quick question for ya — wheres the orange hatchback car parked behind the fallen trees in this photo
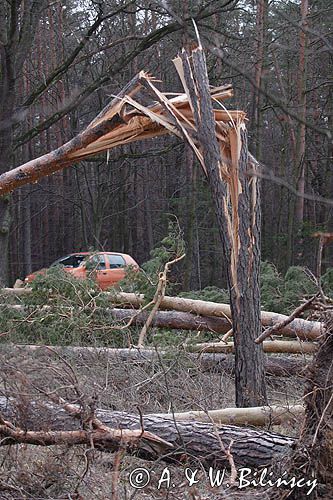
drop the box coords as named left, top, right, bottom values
left=24, top=252, right=139, bottom=290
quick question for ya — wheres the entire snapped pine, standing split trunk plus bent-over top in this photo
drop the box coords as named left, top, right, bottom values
left=0, top=46, right=267, bottom=407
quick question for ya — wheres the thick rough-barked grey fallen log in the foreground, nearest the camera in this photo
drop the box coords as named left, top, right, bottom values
left=0, top=397, right=295, bottom=467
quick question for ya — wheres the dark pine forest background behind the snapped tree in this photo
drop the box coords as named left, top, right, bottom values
left=0, top=0, right=333, bottom=290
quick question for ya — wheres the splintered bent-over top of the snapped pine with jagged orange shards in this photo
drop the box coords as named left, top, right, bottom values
left=0, top=68, right=246, bottom=196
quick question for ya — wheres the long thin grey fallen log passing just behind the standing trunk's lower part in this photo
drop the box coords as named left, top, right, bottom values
left=1, top=344, right=307, bottom=377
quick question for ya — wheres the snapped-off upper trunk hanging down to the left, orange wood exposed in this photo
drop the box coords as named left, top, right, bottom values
left=0, top=71, right=237, bottom=196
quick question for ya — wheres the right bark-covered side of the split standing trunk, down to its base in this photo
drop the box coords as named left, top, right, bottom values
left=228, top=130, right=267, bottom=407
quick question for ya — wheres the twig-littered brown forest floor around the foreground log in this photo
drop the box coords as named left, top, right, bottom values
left=0, top=347, right=303, bottom=500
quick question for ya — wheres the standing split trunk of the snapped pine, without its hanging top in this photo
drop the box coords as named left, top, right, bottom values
left=182, top=47, right=267, bottom=407
